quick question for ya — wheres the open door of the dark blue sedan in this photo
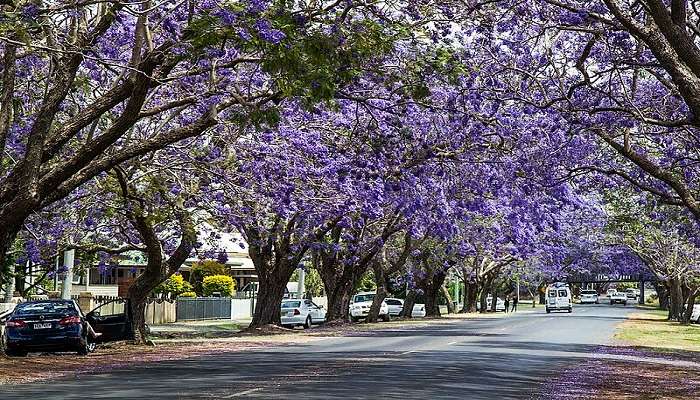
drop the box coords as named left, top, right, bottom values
left=85, top=299, right=134, bottom=343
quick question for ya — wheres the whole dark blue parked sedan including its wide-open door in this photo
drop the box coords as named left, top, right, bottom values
left=2, top=300, right=133, bottom=356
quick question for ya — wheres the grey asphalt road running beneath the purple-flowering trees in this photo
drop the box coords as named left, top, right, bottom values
left=0, top=304, right=634, bottom=400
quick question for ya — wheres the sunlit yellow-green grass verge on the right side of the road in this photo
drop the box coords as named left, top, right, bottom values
left=615, top=307, right=700, bottom=352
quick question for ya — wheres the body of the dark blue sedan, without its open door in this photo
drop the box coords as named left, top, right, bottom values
left=2, top=300, right=95, bottom=356
